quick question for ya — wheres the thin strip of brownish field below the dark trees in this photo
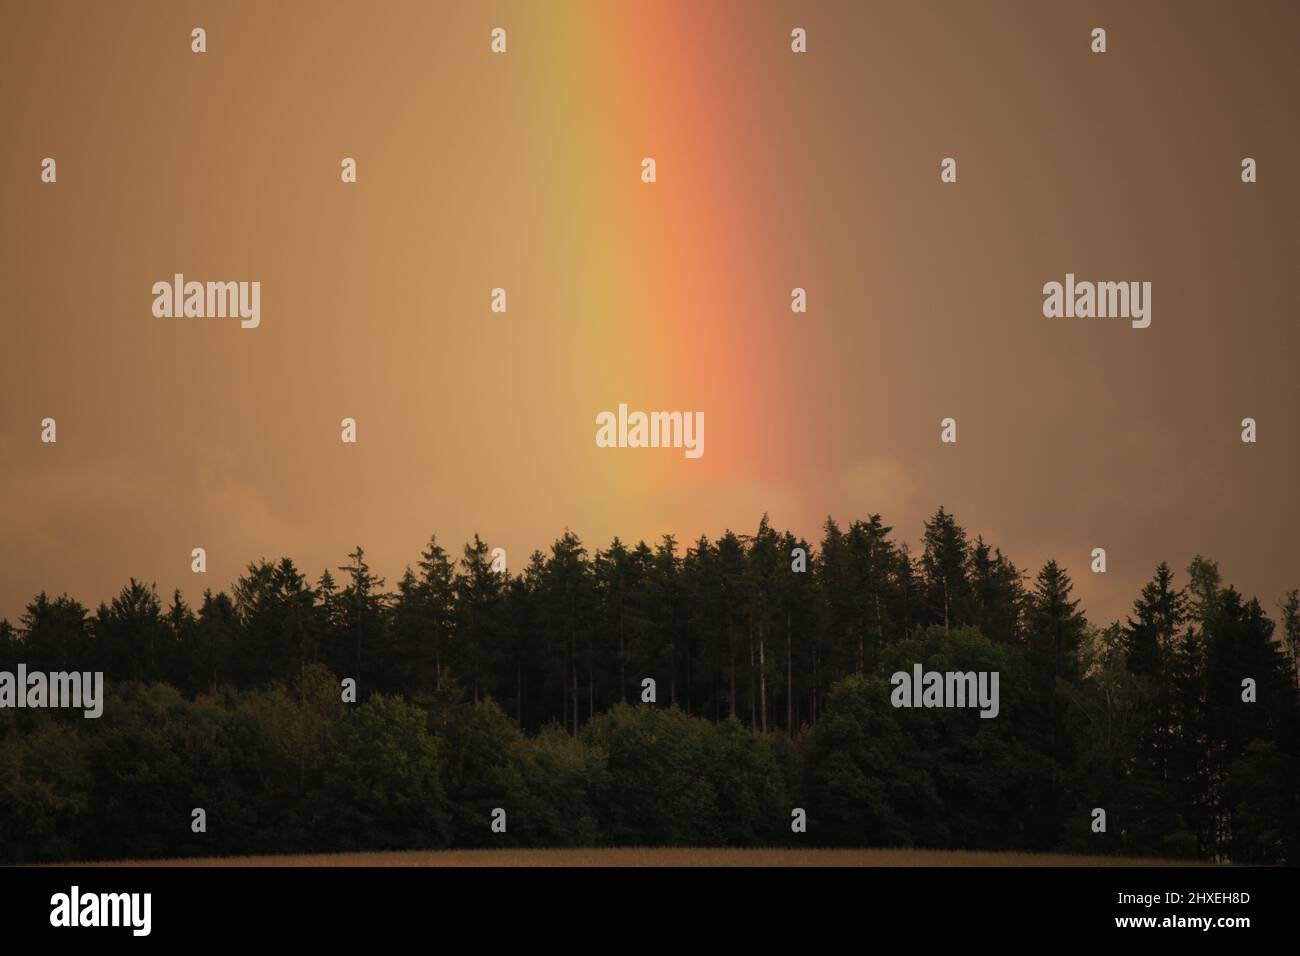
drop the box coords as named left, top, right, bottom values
left=76, top=847, right=1201, bottom=866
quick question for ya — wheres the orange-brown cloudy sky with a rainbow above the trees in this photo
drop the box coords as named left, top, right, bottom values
left=0, top=0, right=1300, bottom=623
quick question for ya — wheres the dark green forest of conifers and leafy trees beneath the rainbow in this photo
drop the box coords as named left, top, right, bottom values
left=0, top=510, right=1300, bottom=862
